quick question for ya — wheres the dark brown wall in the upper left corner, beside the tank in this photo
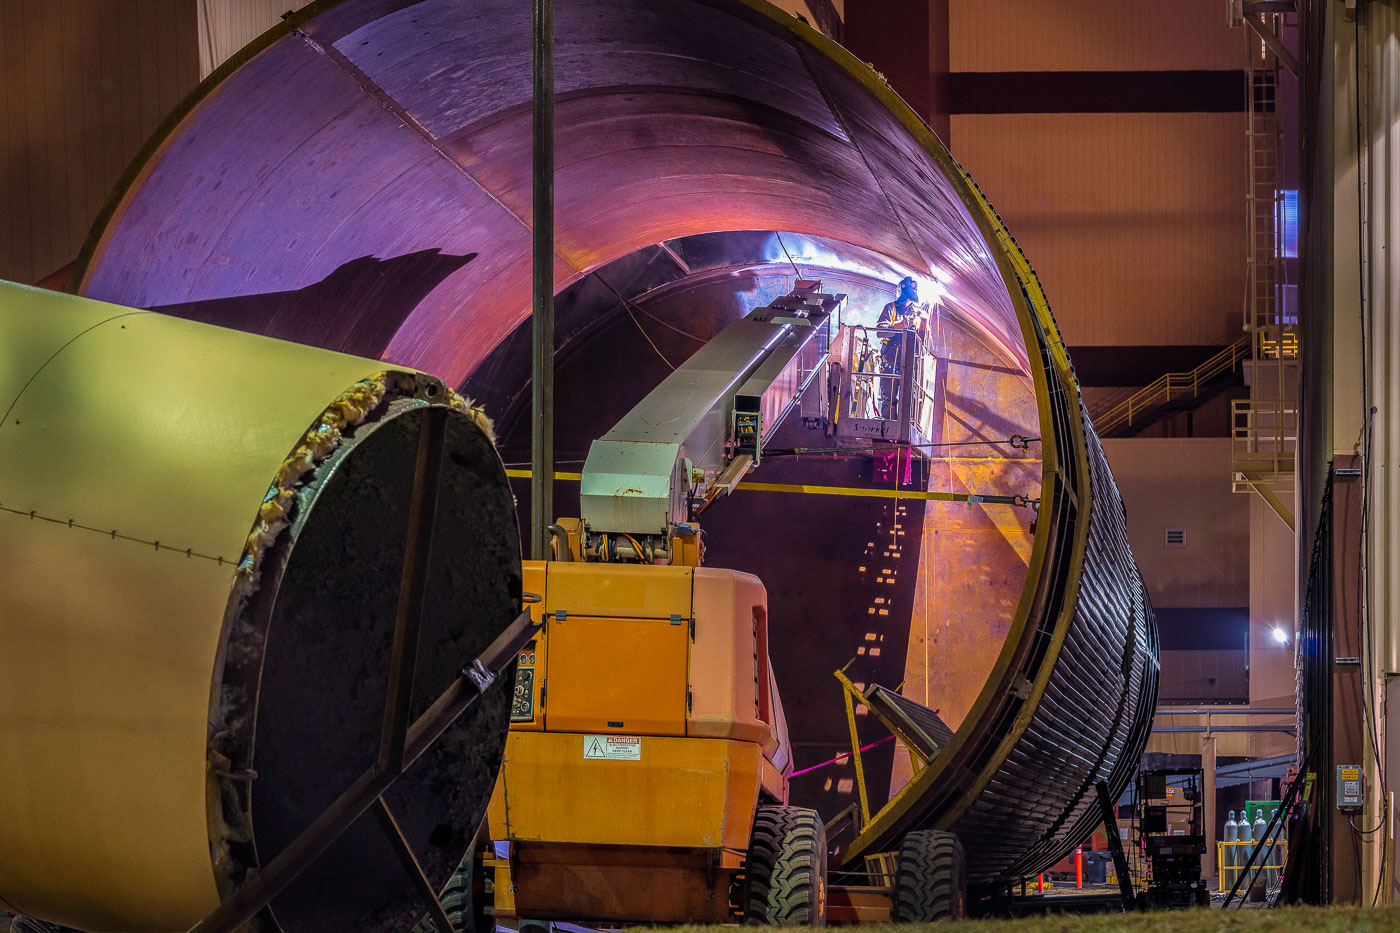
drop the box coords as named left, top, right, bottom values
left=0, top=0, right=199, bottom=282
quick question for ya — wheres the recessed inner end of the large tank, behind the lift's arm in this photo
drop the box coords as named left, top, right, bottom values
left=466, top=231, right=1040, bottom=815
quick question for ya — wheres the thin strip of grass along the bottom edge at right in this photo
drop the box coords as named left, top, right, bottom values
left=668, top=906, right=1400, bottom=933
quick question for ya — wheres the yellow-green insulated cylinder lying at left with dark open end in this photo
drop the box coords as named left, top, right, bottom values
left=0, top=283, right=521, bottom=933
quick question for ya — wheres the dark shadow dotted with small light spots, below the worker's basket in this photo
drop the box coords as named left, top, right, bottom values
left=700, top=406, right=925, bottom=823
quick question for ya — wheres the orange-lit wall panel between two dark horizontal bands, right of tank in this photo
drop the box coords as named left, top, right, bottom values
left=952, top=113, right=1247, bottom=344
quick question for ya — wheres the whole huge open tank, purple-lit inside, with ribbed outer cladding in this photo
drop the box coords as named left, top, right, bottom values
left=65, top=0, right=1156, bottom=902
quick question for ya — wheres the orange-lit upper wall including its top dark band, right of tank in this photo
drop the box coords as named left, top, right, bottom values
left=949, top=0, right=1247, bottom=354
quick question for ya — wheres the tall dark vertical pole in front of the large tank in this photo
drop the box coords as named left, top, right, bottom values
left=529, top=0, right=554, bottom=560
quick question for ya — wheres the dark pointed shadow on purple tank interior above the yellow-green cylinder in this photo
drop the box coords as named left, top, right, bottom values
left=150, top=248, right=477, bottom=357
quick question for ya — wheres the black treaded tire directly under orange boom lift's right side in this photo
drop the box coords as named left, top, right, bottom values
left=743, top=807, right=826, bottom=926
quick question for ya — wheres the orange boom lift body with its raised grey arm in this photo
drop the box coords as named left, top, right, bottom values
left=482, top=282, right=844, bottom=925
